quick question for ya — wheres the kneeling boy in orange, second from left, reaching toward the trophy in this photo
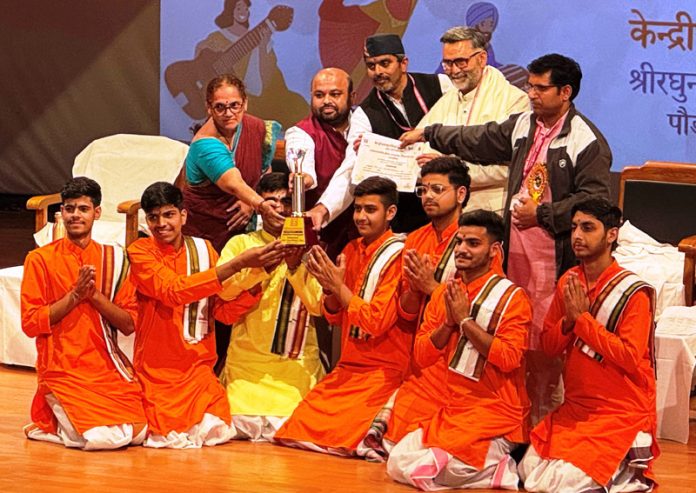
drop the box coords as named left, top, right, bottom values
left=128, top=182, right=282, bottom=448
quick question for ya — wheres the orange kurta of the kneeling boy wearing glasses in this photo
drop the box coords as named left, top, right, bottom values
left=385, top=220, right=458, bottom=442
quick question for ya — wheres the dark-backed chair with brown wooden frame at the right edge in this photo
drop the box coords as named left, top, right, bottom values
left=619, top=161, right=696, bottom=306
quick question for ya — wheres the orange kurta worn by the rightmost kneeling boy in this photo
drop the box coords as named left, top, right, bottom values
left=531, top=261, right=659, bottom=485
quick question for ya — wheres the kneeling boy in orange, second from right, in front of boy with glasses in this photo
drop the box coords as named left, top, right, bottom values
left=387, top=210, right=531, bottom=490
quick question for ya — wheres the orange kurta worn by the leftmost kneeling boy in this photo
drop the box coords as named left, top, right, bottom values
left=21, top=238, right=146, bottom=434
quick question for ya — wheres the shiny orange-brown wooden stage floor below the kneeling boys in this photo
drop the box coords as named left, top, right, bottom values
left=0, top=365, right=696, bottom=493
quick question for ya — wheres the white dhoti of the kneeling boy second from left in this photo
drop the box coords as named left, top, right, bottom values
left=143, top=413, right=237, bottom=449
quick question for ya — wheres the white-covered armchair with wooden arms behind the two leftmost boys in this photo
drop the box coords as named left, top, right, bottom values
left=0, top=134, right=188, bottom=366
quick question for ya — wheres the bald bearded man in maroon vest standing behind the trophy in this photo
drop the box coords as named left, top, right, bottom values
left=285, top=68, right=358, bottom=260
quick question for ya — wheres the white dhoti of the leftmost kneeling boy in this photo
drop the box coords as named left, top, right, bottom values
left=24, top=394, right=147, bottom=450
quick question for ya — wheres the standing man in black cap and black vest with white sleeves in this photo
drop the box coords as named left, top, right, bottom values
left=309, top=34, right=452, bottom=232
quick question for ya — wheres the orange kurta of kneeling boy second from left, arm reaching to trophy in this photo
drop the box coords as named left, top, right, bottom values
left=128, top=238, right=231, bottom=435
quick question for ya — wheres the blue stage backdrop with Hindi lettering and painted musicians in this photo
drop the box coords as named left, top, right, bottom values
left=160, top=0, right=696, bottom=170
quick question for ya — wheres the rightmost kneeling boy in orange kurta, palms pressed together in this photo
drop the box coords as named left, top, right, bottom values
left=520, top=199, right=659, bottom=493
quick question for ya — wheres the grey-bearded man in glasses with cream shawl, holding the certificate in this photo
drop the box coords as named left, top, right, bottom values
left=418, top=26, right=529, bottom=215
